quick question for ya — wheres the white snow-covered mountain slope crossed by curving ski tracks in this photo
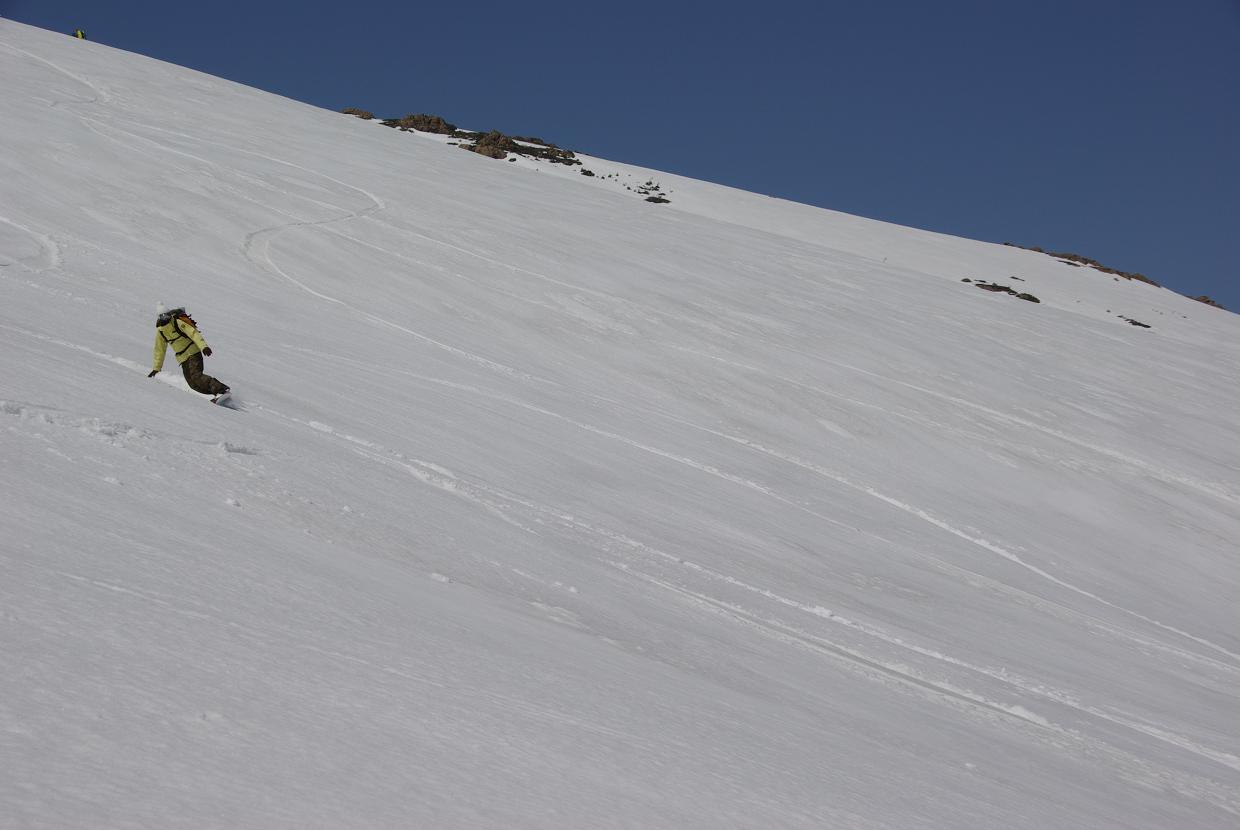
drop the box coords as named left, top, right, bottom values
left=0, top=21, right=1240, bottom=830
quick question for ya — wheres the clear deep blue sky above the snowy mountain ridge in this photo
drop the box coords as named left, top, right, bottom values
left=0, top=0, right=1240, bottom=311
